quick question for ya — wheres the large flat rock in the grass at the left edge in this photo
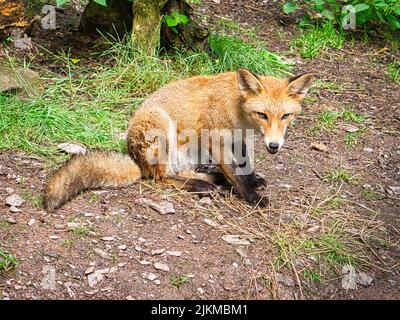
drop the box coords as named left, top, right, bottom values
left=0, top=66, right=43, bottom=96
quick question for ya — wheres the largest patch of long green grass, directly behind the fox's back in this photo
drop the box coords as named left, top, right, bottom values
left=0, top=36, right=291, bottom=160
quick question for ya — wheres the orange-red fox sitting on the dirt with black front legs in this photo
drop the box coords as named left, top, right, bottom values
left=44, top=69, right=314, bottom=210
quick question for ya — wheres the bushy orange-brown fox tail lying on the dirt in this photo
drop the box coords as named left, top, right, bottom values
left=44, top=151, right=141, bottom=210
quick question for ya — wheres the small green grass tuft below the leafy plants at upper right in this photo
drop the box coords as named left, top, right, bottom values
left=290, top=22, right=345, bottom=59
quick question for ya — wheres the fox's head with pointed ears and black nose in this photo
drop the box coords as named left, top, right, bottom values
left=237, top=69, right=314, bottom=153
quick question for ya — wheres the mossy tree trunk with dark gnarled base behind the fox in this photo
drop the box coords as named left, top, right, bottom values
left=78, top=0, right=209, bottom=55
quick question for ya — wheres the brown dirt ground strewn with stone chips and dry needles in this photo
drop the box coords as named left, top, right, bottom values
left=0, top=0, right=400, bottom=299
